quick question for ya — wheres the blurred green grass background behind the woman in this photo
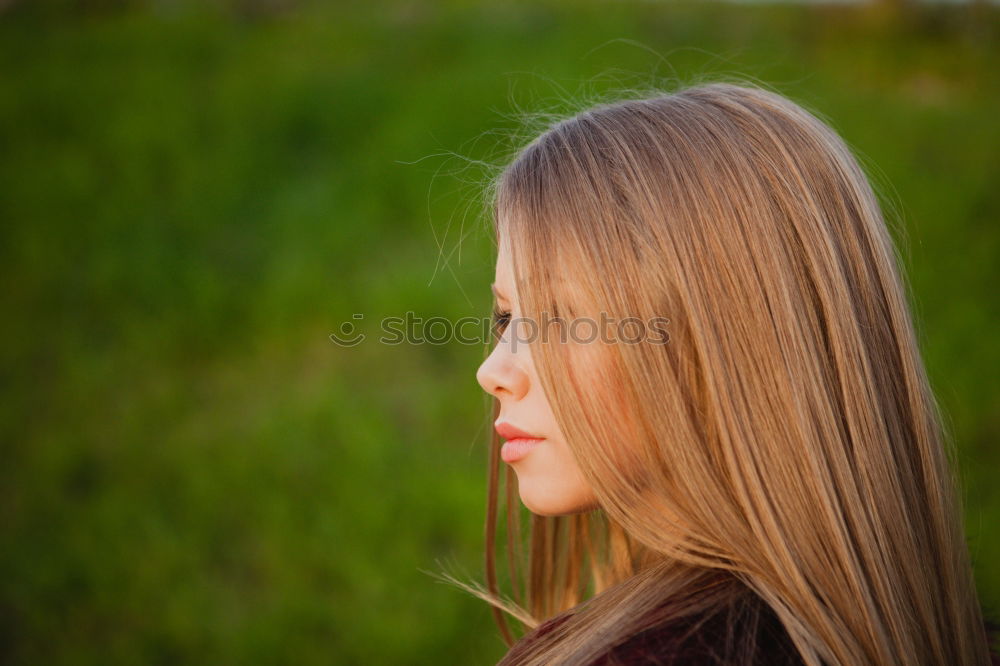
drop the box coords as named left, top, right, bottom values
left=0, top=2, right=1000, bottom=664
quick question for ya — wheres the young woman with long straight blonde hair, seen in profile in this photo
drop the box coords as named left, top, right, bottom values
left=467, top=83, right=990, bottom=665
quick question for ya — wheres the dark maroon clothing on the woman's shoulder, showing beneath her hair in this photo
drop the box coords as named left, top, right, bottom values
left=593, top=592, right=804, bottom=666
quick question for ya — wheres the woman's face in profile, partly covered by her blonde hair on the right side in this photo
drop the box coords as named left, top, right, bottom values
left=476, top=237, right=597, bottom=515
